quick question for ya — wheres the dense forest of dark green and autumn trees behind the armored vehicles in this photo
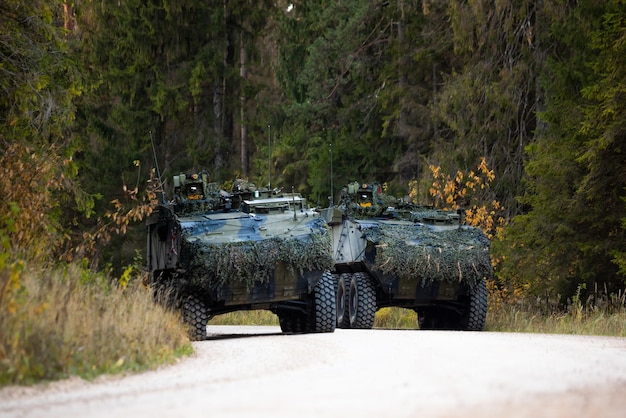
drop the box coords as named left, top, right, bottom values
left=0, top=0, right=626, bottom=304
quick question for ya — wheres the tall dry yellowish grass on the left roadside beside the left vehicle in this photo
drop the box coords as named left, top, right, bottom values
left=0, top=265, right=191, bottom=385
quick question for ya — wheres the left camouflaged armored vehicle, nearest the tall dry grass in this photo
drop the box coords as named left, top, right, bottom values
left=147, top=173, right=336, bottom=340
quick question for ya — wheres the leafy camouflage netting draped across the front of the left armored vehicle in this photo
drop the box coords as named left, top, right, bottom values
left=181, top=230, right=333, bottom=289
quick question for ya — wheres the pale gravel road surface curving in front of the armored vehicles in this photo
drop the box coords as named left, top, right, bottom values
left=0, top=326, right=626, bottom=418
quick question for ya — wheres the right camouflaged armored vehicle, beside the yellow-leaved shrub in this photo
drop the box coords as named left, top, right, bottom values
left=322, top=182, right=492, bottom=331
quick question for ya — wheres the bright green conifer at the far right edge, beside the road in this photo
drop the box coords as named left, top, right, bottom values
left=501, top=2, right=626, bottom=296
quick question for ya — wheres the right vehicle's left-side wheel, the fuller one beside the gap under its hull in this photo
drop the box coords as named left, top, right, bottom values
left=348, top=273, right=376, bottom=329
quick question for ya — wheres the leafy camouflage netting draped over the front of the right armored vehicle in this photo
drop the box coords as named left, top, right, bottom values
left=365, top=225, right=492, bottom=287
